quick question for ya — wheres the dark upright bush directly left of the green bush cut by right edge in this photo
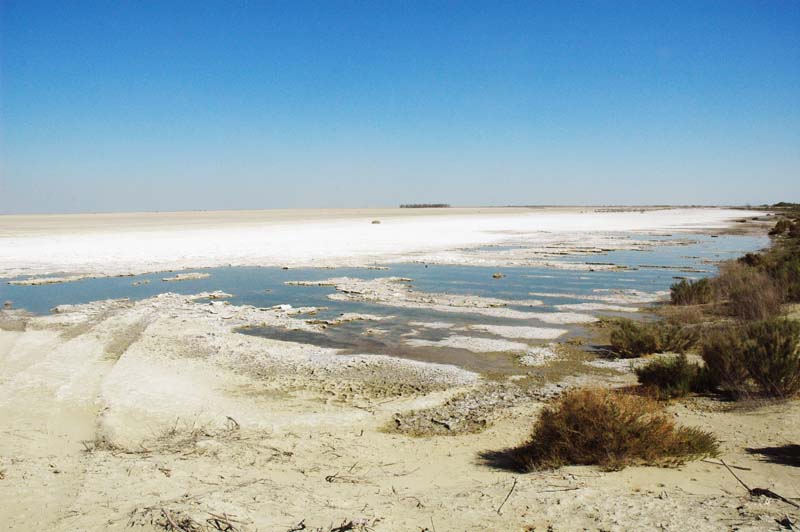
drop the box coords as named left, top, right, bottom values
left=697, top=327, right=749, bottom=396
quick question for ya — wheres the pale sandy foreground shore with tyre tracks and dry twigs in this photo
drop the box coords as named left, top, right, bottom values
left=0, top=294, right=800, bottom=531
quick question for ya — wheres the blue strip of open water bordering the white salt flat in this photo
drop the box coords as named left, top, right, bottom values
left=0, top=235, right=769, bottom=315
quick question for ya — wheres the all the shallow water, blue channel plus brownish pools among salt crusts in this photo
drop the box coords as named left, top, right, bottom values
left=0, top=235, right=769, bottom=374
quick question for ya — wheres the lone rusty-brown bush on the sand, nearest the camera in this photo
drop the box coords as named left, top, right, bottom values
left=513, top=389, right=718, bottom=471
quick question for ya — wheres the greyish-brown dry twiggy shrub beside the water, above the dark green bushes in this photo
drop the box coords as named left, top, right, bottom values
left=716, top=261, right=783, bottom=320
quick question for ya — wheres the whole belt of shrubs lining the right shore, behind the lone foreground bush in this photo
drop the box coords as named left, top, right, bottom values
left=648, top=204, right=800, bottom=398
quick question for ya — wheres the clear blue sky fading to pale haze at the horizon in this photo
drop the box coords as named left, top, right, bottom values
left=0, top=0, right=800, bottom=213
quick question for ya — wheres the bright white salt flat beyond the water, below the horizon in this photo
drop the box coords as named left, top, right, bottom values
left=0, top=208, right=763, bottom=277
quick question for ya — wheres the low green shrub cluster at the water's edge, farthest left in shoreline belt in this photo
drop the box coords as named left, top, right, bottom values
left=609, top=319, right=698, bottom=358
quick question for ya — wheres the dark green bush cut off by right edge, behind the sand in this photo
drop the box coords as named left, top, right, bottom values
left=743, top=319, right=800, bottom=397
